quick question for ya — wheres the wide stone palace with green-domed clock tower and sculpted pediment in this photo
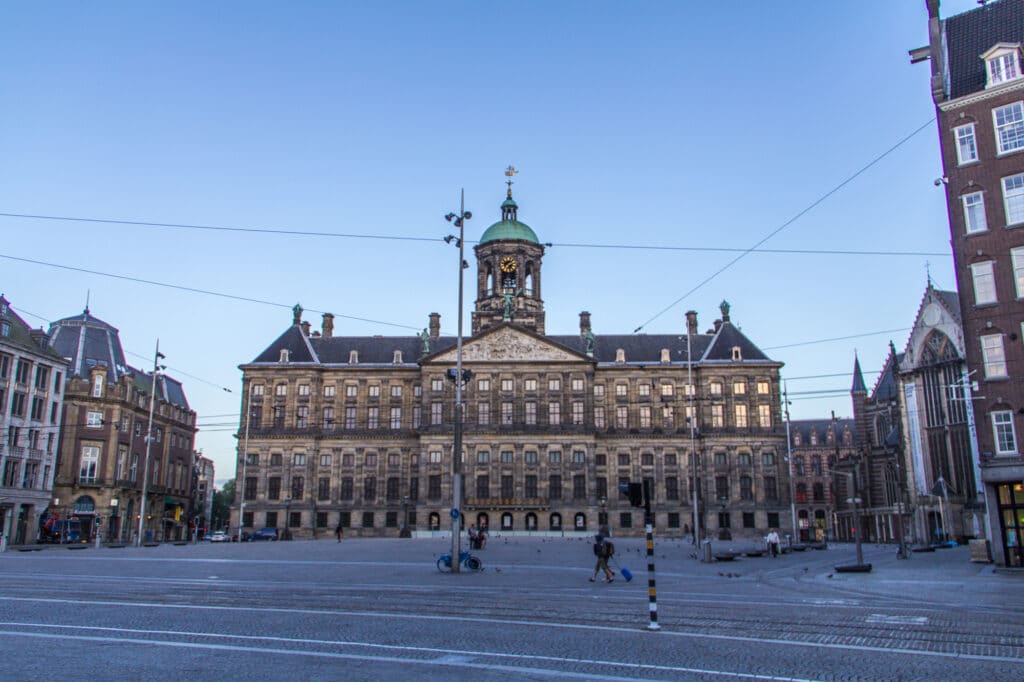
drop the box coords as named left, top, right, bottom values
left=232, top=183, right=792, bottom=538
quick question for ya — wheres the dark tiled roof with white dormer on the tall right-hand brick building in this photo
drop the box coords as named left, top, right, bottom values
left=943, top=0, right=1024, bottom=99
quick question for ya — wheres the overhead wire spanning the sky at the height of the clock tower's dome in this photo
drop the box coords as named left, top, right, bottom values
left=0, top=213, right=950, bottom=258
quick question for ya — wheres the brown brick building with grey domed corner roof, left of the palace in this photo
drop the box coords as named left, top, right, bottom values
left=49, top=308, right=196, bottom=542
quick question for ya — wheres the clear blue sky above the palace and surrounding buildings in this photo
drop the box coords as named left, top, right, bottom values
left=0, top=0, right=976, bottom=479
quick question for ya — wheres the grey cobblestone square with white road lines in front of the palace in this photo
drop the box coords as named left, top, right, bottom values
left=0, top=536, right=1024, bottom=682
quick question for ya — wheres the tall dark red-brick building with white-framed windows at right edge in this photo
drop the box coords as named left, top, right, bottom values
left=910, top=0, right=1024, bottom=566
